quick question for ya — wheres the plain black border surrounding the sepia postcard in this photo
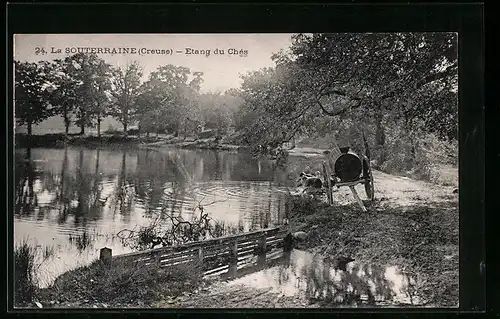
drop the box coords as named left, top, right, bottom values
left=6, top=2, right=490, bottom=317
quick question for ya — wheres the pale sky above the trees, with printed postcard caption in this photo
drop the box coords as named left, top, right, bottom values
left=14, top=33, right=291, bottom=92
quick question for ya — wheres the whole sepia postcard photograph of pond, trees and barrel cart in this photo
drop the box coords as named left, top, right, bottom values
left=12, top=32, right=459, bottom=309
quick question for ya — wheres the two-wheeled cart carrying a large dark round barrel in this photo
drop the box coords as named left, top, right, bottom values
left=323, top=147, right=375, bottom=211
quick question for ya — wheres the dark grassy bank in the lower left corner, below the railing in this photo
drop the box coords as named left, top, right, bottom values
left=15, top=245, right=206, bottom=308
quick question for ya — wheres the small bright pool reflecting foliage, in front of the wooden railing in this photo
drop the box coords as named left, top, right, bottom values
left=228, top=249, right=424, bottom=307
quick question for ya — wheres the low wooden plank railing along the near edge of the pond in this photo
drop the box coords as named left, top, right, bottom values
left=100, top=226, right=287, bottom=271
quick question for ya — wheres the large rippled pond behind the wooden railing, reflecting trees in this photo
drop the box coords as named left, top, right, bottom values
left=14, top=147, right=304, bottom=286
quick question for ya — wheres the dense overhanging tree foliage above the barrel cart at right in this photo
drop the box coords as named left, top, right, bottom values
left=233, top=33, right=458, bottom=175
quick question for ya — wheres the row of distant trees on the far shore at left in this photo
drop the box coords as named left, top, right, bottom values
left=15, top=53, right=244, bottom=140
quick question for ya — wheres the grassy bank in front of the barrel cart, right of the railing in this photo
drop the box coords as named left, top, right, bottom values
left=284, top=194, right=459, bottom=307
